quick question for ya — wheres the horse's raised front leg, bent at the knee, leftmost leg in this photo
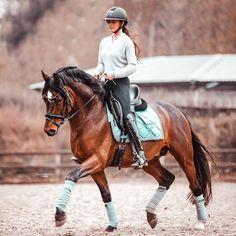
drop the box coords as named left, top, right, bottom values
left=55, top=155, right=104, bottom=227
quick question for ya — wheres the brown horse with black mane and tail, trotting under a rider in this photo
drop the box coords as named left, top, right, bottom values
left=42, top=67, right=212, bottom=231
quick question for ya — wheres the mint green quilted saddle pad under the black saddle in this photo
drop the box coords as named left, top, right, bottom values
left=106, top=106, right=164, bottom=143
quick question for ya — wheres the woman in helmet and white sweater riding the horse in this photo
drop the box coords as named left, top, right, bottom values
left=95, top=7, right=147, bottom=168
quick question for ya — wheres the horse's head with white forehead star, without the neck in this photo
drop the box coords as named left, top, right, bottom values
left=41, top=71, right=73, bottom=136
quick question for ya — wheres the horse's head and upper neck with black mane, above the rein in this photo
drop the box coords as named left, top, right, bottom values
left=42, top=67, right=105, bottom=136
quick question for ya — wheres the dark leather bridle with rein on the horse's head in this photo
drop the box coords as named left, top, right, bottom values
left=43, top=92, right=96, bottom=128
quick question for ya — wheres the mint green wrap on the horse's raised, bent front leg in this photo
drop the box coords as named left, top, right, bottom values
left=56, top=180, right=75, bottom=211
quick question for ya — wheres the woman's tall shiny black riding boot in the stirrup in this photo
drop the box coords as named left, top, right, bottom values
left=125, top=114, right=148, bottom=169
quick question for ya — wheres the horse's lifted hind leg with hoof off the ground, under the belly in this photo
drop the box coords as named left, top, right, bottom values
left=143, top=159, right=175, bottom=228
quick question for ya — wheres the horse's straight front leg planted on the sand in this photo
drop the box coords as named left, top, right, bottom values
left=92, top=171, right=118, bottom=232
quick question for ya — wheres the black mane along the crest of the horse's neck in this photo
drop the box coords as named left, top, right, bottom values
left=44, top=66, right=105, bottom=101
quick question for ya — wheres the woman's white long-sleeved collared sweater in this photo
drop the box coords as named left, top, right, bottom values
left=97, top=33, right=137, bottom=78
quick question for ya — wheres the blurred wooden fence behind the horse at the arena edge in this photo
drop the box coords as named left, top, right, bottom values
left=0, top=148, right=236, bottom=184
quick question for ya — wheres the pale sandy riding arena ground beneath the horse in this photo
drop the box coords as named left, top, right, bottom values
left=0, top=179, right=236, bottom=236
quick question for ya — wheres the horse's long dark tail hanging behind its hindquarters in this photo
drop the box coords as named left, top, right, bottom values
left=188, top=128, right=215, bottom=205
